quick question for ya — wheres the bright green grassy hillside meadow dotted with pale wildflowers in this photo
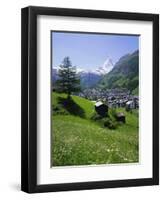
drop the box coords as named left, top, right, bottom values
left=52, top=92, right=138, bottom=166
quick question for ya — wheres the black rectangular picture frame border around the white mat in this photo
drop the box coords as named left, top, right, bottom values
left=21, top=6, right=159, bottom=193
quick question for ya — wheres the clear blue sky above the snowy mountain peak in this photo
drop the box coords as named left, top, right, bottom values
left=52, top=32, right=139, bottom=70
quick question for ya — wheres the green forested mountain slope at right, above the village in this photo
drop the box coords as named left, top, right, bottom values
left=98, top=50, right=139, bottom=94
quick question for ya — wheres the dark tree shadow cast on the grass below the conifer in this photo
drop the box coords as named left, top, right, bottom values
left=58, top=97, right=85, bottom=118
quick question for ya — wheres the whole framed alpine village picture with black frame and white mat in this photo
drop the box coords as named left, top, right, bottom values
left=21, top=6, right=159, bottom=193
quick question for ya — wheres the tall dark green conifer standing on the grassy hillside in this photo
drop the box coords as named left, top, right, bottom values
left=56, top=57, right=80, bottom=98
